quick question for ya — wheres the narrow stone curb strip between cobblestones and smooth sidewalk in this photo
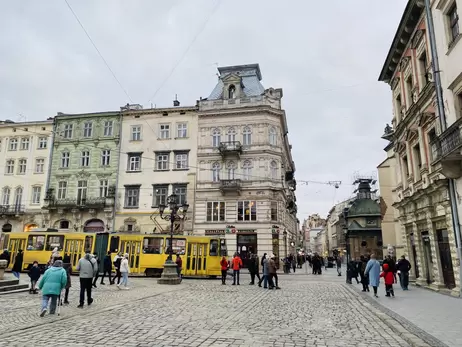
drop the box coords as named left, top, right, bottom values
left=343, top=284, right=449, bottom=347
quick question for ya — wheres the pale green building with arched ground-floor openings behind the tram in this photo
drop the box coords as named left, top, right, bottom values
left=43, top=112, right=121, bottom=232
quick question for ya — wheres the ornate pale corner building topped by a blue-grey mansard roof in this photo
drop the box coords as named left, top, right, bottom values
left=194, top=64, right=297, bottom=262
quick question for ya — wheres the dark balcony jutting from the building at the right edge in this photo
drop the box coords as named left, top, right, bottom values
left=430, top=118, right=462, bottom=179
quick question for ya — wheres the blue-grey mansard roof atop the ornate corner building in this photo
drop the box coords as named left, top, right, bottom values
left=208, top=64, right=265, bottom=100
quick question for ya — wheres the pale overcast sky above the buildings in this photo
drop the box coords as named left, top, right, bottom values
left=0, top=0, right=406, bottom=220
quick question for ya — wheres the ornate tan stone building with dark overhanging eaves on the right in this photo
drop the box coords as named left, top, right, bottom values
left=379, top=0, right=462, bottom=295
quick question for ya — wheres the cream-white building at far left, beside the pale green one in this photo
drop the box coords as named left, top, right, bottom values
left=0, top=120, right=53, bottom=232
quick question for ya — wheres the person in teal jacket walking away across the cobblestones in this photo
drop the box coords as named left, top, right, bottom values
left=38, top=260, right=67, bottom=317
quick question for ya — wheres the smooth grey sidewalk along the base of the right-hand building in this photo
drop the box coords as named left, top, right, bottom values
left=353, top=280, right=462, bottom=347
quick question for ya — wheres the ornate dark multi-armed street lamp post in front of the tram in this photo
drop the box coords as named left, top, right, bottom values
left=157, top=194, right=189, bottom=284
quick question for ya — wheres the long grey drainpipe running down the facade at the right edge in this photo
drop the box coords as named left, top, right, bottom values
left=425, top=0, right=462, bottom=296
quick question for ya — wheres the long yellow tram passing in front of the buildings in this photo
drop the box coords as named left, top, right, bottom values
left=3, top=231, right=227, bottom=277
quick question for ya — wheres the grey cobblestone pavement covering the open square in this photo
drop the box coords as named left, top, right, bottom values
left=0, top=271, right=444, bottom=347
